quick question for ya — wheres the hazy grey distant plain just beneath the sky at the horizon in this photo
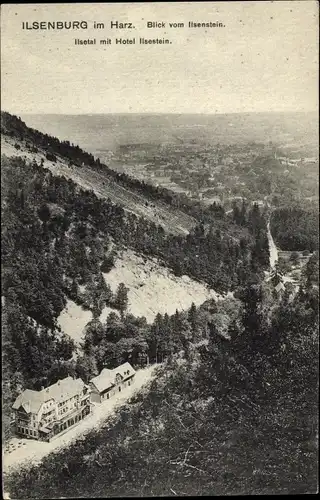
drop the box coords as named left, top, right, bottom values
left=19, top=112, right=318, bottom=152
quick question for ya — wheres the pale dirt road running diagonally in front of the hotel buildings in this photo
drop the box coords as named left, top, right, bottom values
left=3, top=365, right=159, bottom=473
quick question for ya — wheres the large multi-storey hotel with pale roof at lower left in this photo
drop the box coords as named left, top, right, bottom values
left=12, top=377, right=91, bottom=441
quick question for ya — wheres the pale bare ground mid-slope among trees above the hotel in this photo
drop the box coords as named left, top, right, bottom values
left=57, top=249, right=223, bottom=344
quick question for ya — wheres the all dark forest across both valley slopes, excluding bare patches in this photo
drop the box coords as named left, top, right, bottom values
left=1, top=110, right=319, bottom=498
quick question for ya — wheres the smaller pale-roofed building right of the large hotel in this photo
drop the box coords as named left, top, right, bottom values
left=89, top=363, right=136, bottom=403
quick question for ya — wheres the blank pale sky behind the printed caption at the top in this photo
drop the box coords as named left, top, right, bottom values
left=1, top=0, right=318, bottom=114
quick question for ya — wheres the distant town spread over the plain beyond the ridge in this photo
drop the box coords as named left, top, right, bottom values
left=96, top=140, right=319, bottom=209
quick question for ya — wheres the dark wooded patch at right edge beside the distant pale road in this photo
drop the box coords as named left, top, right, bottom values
left=270, top=205, right=319, bottom=252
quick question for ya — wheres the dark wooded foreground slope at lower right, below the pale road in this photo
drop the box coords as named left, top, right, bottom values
left=7, top=278, right=318, bottom=498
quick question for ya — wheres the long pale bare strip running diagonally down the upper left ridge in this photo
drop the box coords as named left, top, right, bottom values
left=1, top=113, right=196, bottom=234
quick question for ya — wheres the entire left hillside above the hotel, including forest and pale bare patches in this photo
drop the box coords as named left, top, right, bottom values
left=1, top=110, right=268, bottom=446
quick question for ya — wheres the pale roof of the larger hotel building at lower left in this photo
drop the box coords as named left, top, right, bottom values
left=12, top=377, right=85, bottom=413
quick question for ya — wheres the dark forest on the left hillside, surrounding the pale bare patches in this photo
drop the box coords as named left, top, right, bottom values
left=2, top=151, right=268, bottom=438
